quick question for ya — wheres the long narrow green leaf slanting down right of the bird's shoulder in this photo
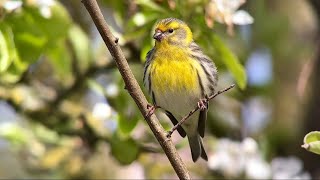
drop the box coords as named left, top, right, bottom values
left=213, top=35, right=247, bottom=89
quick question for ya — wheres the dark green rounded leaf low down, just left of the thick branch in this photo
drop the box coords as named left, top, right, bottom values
left=110, top=134, right=139, bottom=165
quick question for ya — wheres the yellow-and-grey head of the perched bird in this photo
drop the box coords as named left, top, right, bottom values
left=153, top=18, right=193, bottom=46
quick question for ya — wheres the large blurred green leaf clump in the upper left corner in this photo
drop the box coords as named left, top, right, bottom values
left=4, top=2, right=71, bottom=64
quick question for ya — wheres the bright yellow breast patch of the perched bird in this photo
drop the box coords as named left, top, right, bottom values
left=150, top=49, right=199, bottom=93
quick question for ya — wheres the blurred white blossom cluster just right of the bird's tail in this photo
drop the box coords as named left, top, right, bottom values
left=208, top=138, right=271, bottom=179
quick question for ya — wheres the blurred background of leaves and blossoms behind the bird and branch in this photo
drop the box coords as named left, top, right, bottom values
left=0, top=0, right=320, bottom=179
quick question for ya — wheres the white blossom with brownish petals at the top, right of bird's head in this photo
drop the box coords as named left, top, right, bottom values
left=205, top=0, right=254, bottom=35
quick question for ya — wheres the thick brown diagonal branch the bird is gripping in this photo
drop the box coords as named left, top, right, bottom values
left=82, top=0, right=190, bottom=179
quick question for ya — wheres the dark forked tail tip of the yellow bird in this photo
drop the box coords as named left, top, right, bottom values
left=188, top=134, right=208, bottom=162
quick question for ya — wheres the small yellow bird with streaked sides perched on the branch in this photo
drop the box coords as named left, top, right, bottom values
left=143, top=18, right=218, bottom=162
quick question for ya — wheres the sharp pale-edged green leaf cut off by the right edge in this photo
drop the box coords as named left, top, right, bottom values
left=302, top=131, right=320, bottom=154
